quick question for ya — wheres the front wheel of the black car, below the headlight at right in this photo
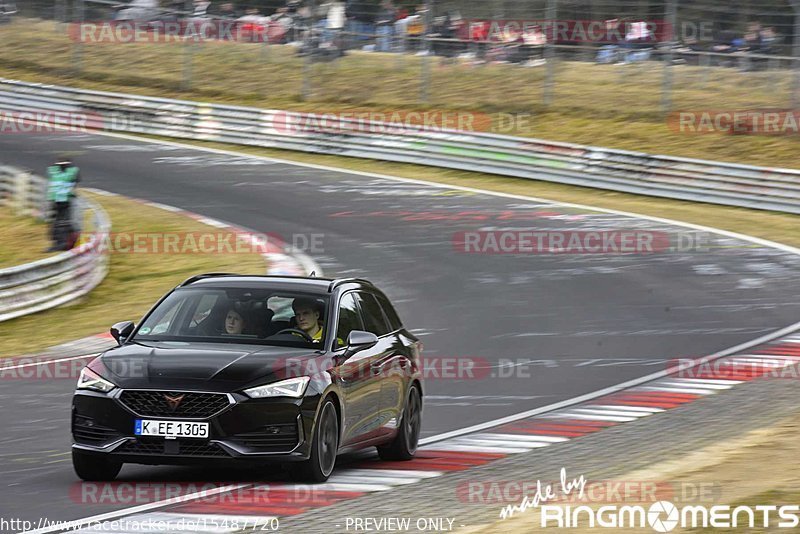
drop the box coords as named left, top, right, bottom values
left=290, top=399, right=339, bottom=482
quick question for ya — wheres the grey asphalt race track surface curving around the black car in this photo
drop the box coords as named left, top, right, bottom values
left=0, top=135, right=800, bottom=520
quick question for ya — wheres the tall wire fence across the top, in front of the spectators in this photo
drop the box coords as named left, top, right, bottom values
left=0, top=0, right=800, bottom=118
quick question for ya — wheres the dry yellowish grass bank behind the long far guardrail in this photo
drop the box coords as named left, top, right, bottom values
left=0, top=20, right=800, bottom=167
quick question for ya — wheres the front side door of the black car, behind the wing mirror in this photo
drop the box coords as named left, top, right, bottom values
left=335, top=291, right=381, bottom=446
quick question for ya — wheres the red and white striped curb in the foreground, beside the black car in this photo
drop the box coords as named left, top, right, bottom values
left=32, top=333, right=800, bottom=534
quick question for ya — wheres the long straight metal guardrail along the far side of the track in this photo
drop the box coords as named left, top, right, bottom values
left=0, top=78, right=800, bottom=214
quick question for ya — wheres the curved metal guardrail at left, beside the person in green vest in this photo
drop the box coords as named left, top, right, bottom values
left=0, top=166, right=111, bottom=322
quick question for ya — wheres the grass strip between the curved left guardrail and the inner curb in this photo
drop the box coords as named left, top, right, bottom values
left=0, top=193, right=266, bottom=357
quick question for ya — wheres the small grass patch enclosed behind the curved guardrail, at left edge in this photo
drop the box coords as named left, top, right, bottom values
left=0, top=207, right=52, bottom=268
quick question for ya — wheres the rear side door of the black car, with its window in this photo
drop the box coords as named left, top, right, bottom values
left=358, top=291, right=405, bottom=436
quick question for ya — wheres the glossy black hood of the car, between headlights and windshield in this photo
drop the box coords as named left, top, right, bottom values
left=100, top=342, right=320, bottom=391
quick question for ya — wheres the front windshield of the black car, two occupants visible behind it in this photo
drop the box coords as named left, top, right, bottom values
left=133, top=287, right=328, bottom=348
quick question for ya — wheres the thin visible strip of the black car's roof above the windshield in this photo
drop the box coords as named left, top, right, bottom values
left=178, top=273, right=374, bottom=293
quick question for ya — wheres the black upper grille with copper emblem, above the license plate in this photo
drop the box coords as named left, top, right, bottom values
left=119, top=391, right=230, bottom=417
